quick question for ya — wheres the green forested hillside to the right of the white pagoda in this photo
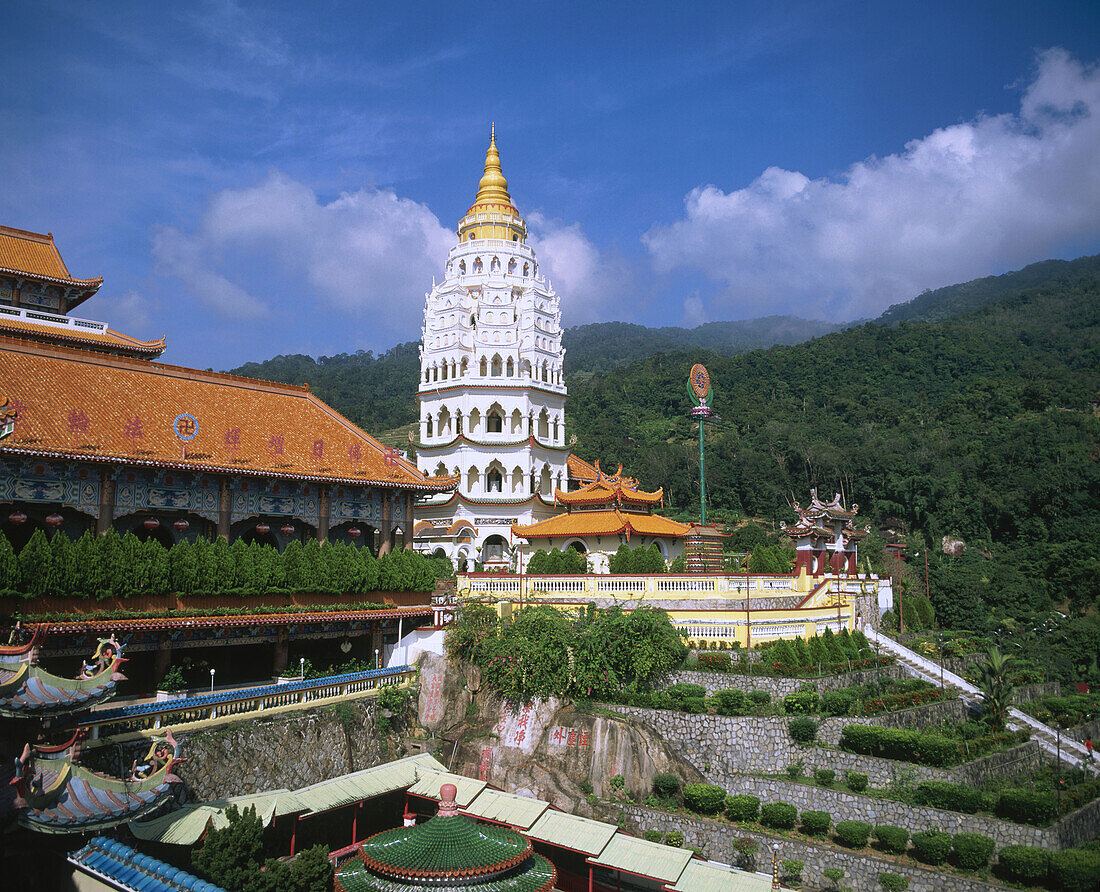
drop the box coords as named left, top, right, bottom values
left=569, top=275, right=1100, bottom=626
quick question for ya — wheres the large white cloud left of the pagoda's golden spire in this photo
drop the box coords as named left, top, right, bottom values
left=153, top=172, right=454, bottom=336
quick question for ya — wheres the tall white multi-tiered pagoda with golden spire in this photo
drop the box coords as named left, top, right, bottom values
left=414, top=130, right=570, bottom=569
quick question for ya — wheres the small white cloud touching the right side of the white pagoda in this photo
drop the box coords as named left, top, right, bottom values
left=527, top=211, right=634, bottom=327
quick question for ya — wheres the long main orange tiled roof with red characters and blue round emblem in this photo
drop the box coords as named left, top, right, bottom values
left=0, top=337, right=457, bottom=492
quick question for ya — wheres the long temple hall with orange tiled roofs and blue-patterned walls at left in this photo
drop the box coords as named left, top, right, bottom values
left=0, top=227, right=454, bottom=553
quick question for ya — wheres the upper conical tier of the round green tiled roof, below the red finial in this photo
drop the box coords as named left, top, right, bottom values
left=362, top=815, right=530, bottom=873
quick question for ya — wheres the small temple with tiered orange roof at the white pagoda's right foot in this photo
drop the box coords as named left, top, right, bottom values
left=512, top=455, right=691, bottom=573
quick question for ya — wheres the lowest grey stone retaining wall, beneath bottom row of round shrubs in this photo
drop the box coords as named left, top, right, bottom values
left=601, top=805, right=1005, bottom=892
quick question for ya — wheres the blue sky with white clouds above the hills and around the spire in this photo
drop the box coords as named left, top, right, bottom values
left=0, top=0, right=1100, bottom=368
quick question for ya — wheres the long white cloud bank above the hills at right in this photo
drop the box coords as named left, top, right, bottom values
left=642, top=49, right=1100, bottom=319
